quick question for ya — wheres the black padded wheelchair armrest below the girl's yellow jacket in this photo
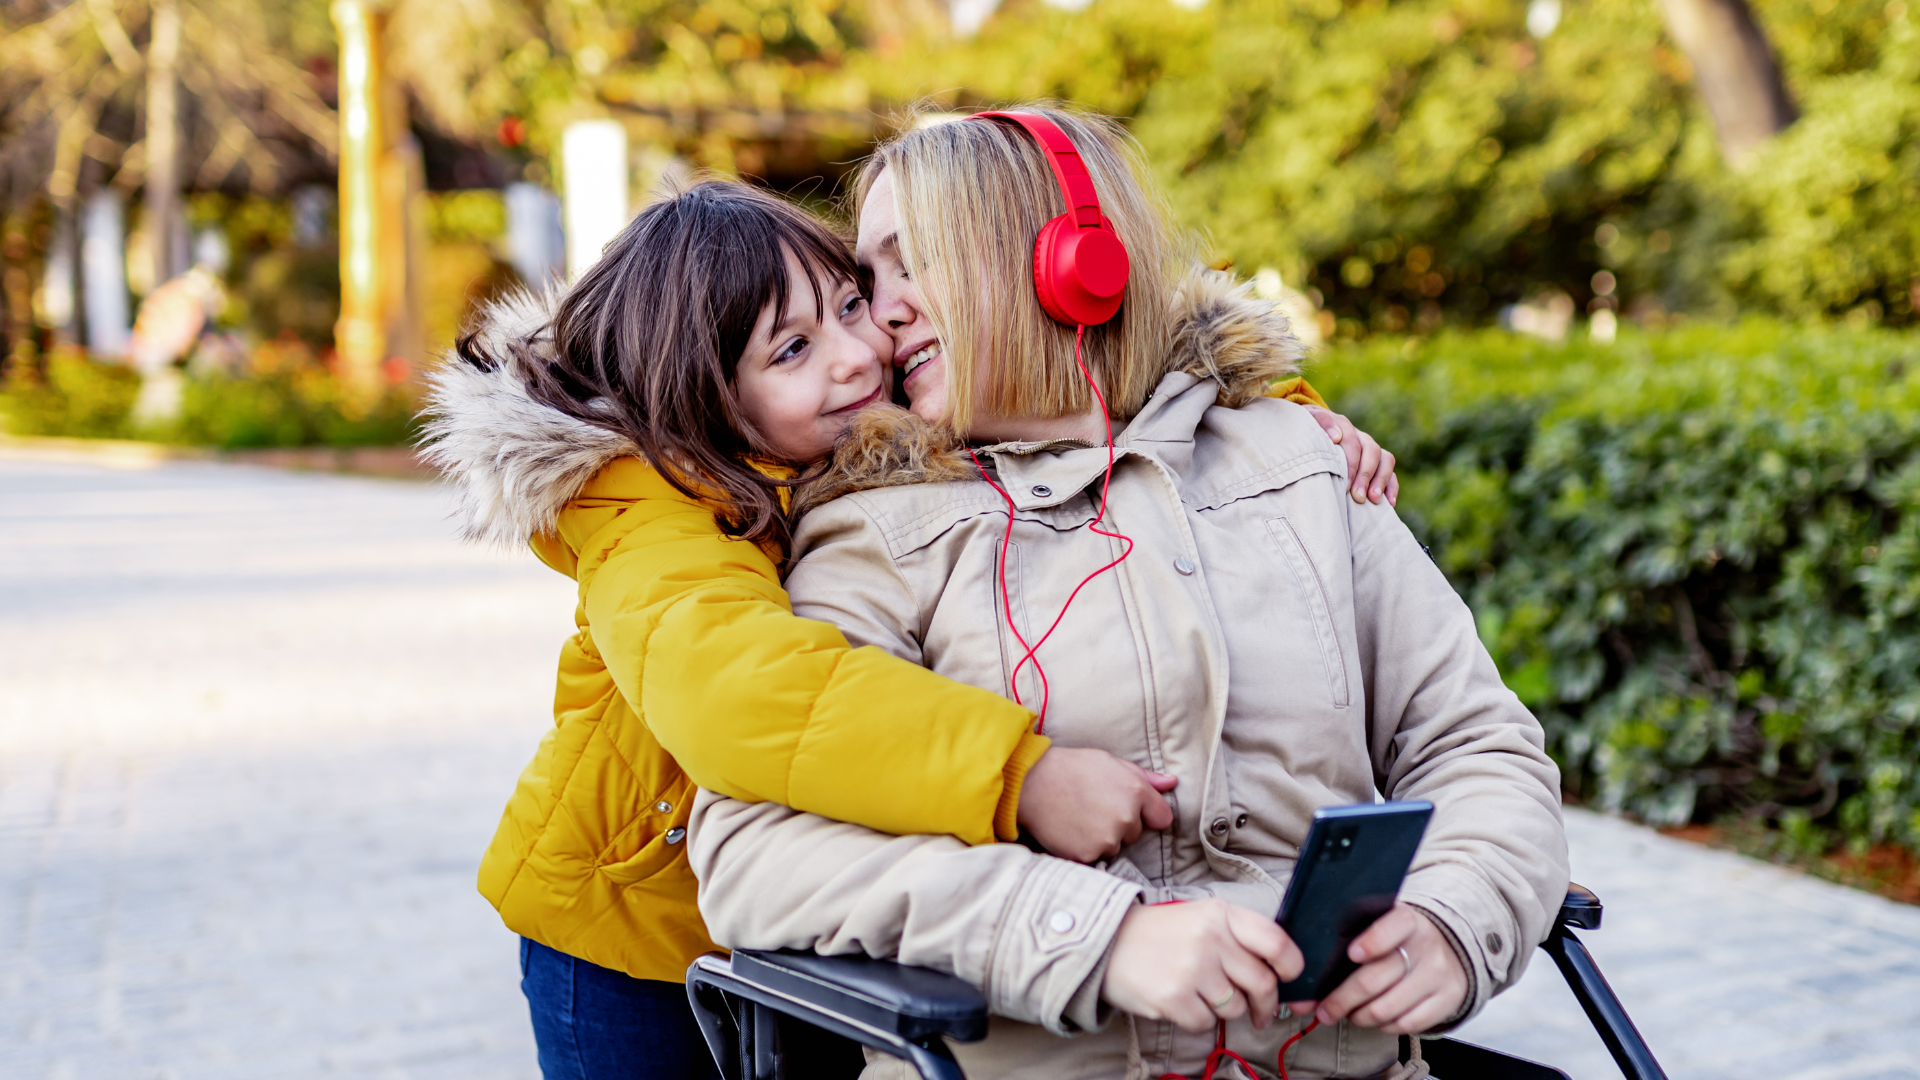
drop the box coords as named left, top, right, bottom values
left=733, top=949, right=987, bottom=1042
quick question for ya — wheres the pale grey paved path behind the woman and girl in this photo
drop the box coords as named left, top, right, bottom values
left=0, top=459, right=1920, bottom=1080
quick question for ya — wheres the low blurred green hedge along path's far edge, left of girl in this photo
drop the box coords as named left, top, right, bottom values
left=0, top=350, right=417, bottom=450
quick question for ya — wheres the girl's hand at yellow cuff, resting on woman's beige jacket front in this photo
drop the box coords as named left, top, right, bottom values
left=1014, top=744, right=1179, bottom=863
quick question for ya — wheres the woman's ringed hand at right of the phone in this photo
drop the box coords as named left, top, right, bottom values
left=1290, top=903, right=1467, bottom=1036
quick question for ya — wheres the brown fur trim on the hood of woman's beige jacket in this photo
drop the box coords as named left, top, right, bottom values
left=793, top=269, right=1306, bottom=517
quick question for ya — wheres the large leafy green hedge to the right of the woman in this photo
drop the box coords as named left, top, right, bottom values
left=1311, top=321, right=1920, bottom=849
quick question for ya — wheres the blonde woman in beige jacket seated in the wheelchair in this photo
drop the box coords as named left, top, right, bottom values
left=691, top=110, right=1567, bottom=1080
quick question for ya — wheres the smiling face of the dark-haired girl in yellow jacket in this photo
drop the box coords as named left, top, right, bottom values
left=733, top=254, right=893, bottom=461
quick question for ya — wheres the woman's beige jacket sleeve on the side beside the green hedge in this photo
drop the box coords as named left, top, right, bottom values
left=1338, top=488, right=1567, bottom=1022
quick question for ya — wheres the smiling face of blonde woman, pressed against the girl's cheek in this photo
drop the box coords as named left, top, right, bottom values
left=854, top=171, right=947, bottom=423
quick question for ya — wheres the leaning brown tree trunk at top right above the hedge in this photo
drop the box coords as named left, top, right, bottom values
left=1661, top=0, right=1799, bottom=167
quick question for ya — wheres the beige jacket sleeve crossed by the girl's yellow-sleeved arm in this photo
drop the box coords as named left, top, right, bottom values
left=687, top=498, right=1139, bottom=1034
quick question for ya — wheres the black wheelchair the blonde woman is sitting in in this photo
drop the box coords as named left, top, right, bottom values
left=687, top=886, right=1667, bottom=1080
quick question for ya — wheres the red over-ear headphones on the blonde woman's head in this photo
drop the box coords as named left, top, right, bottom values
left=968, top=111, right=1129, bottom=327
